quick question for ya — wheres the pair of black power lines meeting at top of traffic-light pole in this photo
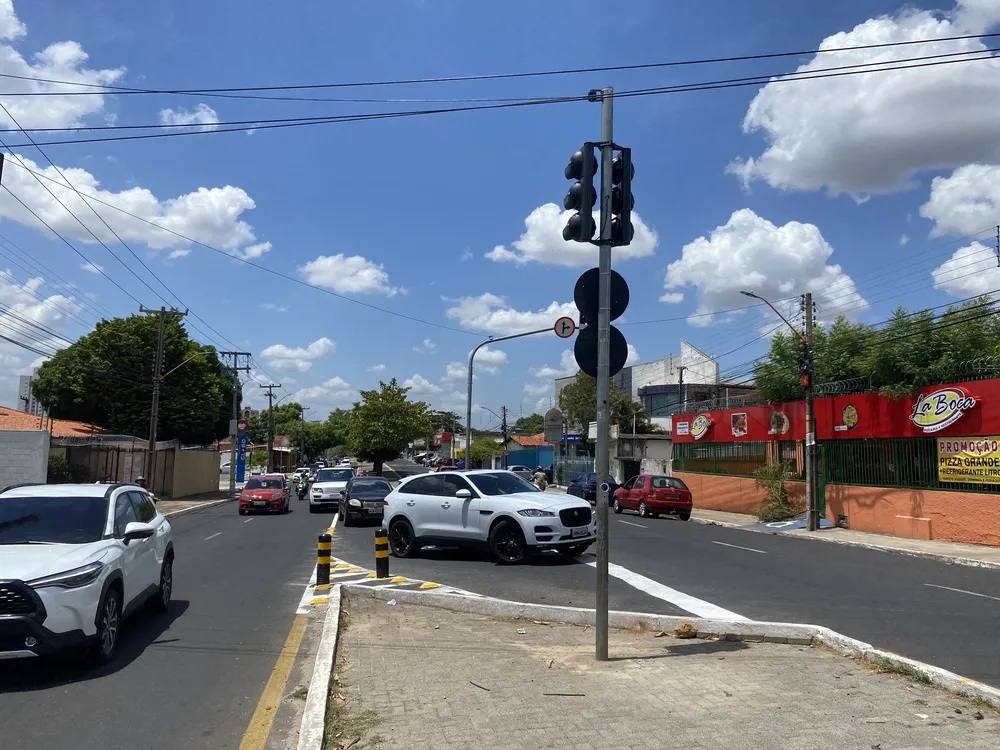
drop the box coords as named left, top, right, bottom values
left=3, top=48, right=1000, bottom=148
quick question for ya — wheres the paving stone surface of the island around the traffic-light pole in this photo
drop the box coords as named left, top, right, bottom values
left=334, top=596, right=1000, bottom=750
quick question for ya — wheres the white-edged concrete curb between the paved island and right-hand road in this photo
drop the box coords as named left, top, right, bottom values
left=341, top=583, right=1000, bottom=709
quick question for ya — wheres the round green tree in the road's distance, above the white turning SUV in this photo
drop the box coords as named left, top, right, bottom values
left=347, top=378, right=430, bottom=474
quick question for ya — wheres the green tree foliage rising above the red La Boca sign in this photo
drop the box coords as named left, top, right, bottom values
left=754, top=297, right=1000, bottom=403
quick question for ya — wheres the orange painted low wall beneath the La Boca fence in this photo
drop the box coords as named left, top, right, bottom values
left=675, top=471, right=1000, bottom=547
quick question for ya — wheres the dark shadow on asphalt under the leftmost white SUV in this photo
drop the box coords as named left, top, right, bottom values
left=0, top=600, right=189, bottom=693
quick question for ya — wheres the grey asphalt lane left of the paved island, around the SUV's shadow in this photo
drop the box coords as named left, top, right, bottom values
left=0, top=500, right=330, bottom=750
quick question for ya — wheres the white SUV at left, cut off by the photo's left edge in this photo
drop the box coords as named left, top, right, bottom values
left=0, top=484, right=174, bottom=664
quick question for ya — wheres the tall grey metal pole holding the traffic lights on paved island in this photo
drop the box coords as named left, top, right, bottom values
left=595, top=86, right=614, bottom=661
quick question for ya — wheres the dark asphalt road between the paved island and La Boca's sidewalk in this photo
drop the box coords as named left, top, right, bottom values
left=334, top=500, right=1000, bottom=686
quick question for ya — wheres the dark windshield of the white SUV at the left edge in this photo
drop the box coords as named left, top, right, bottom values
left=0, top=496, right=108, bottom=544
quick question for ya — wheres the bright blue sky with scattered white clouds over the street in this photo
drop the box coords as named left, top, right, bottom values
left=0, top=0, right=1000, bottom=426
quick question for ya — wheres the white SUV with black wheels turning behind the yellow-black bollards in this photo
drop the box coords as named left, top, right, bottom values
left=385, top=470, right=597, bottom=563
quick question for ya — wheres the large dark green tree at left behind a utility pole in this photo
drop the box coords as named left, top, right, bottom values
left=33, top=315, right=233, bottom=445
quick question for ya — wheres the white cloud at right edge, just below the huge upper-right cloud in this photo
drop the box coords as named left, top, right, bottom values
left=920, top=164, right=1000, bottom=237
